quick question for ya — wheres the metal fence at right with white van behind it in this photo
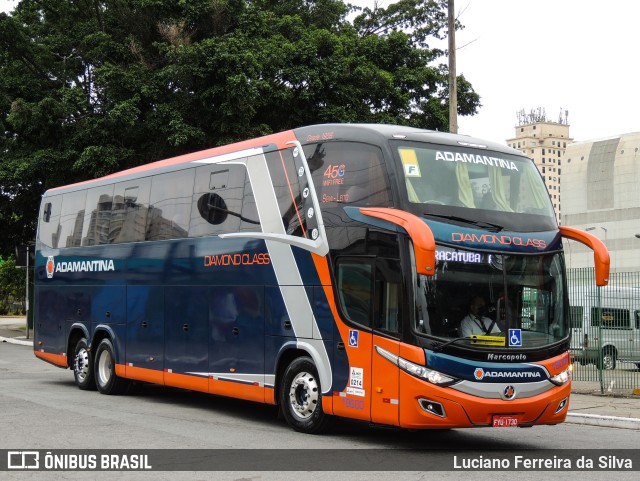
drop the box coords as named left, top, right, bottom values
left=567, top=268, right=640, bottom=391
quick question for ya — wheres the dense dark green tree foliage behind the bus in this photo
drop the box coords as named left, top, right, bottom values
left=0, top=0, right=479, bottom=253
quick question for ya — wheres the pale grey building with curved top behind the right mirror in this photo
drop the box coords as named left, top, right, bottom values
left=562, top=132, right=640, bottom=272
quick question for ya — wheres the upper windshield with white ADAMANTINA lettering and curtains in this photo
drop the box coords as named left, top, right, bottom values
left=394, top=142, right=555, bottom=230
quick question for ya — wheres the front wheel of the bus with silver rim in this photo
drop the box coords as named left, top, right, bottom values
left=280, top=357, right=330, bottom=434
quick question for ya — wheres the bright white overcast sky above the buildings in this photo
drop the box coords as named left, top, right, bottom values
left=0, top=0, right=640, bottom=142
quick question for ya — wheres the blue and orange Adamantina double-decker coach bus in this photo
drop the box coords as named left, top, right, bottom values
left=34, top=124, right=609, bottom=433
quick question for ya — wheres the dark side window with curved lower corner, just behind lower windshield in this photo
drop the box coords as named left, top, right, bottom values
left=337, top=259, right=373, bottom=326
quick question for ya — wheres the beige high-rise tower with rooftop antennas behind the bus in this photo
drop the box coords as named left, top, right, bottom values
left=507, top=108, right=573, bottom=222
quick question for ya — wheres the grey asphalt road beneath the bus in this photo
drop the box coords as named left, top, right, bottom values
left=0, top=343, right=640, bottom=480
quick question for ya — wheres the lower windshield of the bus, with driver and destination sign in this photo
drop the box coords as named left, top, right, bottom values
left=415, top=246, right=569, bottom=348
